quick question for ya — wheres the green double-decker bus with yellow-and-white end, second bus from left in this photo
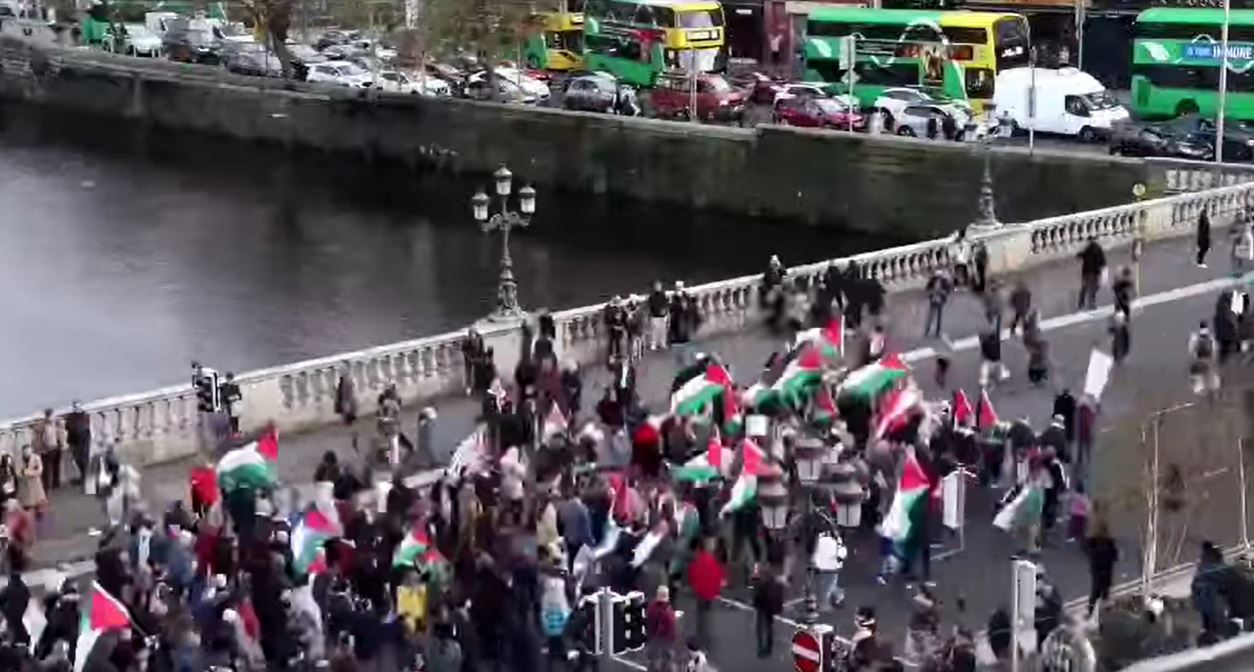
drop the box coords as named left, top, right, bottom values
left=583, top=0, right=726, bottom=87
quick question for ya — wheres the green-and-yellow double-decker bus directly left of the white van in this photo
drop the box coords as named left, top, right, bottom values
left=803, top=8, right=1031, bottom=112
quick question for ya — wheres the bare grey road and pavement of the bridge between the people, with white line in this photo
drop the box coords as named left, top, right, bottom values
left=22, top=231, right=1248, bottom=672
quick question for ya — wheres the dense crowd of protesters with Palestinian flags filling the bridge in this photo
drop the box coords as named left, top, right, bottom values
left=0, top=218, right=1254, bottom=672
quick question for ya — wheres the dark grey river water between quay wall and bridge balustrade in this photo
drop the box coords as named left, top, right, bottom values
left=0, top=105, right=899, bottom=417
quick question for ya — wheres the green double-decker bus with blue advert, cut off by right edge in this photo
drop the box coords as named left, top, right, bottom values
left=1131, top=9, right=1254, bottom=120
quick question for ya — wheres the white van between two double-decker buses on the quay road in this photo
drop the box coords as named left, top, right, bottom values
left=993, top=68, right=1127, bottom=142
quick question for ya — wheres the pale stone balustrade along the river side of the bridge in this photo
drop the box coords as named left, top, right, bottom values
left=0, top=183, right=1254, bottom=464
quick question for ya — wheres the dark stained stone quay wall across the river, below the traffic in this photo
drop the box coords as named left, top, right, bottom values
left=0, top=36, right=1223, bottom=239
